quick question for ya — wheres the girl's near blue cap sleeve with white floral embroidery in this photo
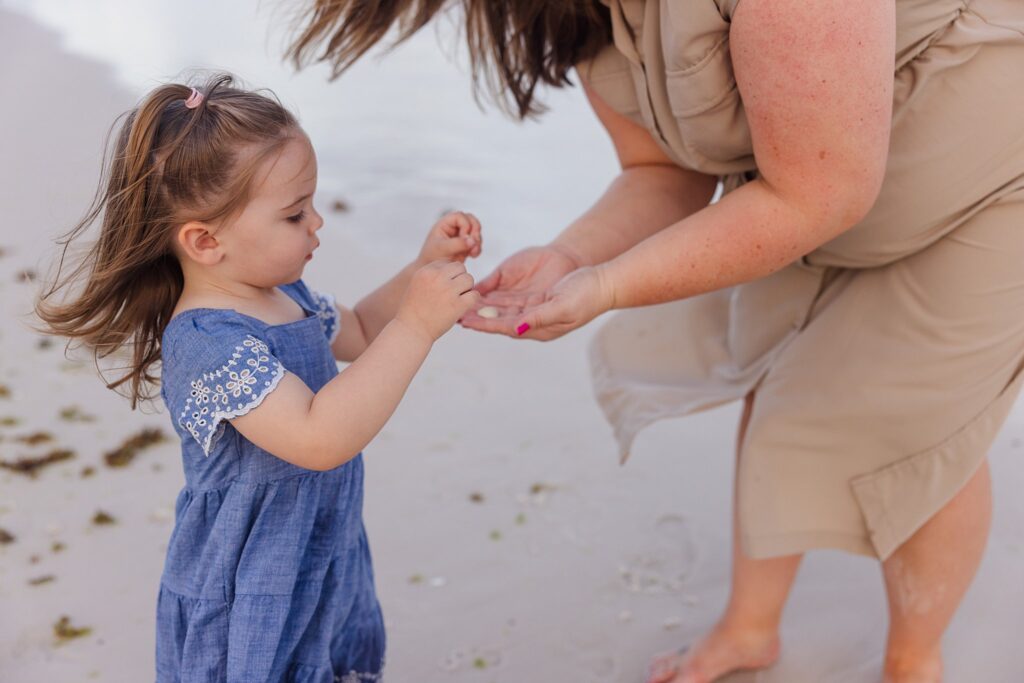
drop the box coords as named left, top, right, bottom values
left=164, top=312, right=285, bottom=456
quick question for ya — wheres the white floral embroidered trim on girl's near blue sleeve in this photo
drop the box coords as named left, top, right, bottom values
left=178, top=335, right=285, bottom=456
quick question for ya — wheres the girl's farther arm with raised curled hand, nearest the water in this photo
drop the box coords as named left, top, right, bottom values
left=331, top=212, right=482, bottom=361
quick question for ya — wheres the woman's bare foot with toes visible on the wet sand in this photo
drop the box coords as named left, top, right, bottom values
left=647, top=625, right=778, bottom=683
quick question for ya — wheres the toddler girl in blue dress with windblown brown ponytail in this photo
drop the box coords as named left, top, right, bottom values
left=37, top=76, right=481, bottom=683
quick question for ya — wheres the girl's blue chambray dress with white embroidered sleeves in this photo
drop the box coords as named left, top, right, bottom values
left=157, top=281, right=385, bottom=683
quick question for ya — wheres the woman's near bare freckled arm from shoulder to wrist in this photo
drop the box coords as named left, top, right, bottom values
left=598, top=0, right=895, bottom=307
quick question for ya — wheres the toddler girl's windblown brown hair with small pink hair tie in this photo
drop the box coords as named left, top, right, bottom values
left=36, top=74, right=298, bottom=409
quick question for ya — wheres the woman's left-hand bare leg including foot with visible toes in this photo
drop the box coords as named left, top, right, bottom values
left=648, top=393, right=803, bottom=683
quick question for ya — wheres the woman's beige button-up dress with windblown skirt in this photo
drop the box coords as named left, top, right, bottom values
left=579, top=0, right=1024, bottom=559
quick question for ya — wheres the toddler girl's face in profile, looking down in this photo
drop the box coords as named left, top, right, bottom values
left=216, top=135, right=324, bottom=288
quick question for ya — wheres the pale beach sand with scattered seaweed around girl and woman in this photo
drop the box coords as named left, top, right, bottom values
left=0, top=10, right=1024, bottom=683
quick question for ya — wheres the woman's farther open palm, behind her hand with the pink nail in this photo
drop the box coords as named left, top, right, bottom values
left=462, top=245, right=580, bottom=337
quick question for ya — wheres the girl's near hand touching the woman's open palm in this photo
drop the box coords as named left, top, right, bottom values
left=395, top=261, right=480, bottom=342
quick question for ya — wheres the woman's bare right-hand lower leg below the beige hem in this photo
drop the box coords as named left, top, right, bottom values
left=882, top=461, right=992, bottom=683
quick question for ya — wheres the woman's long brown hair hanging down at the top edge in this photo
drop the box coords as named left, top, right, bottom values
left=287, top=0, right=610, bottom=119
